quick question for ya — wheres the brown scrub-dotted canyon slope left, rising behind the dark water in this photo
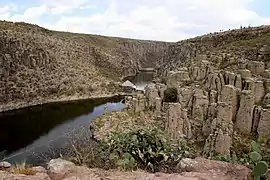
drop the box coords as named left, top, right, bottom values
left=0, top=22, right=168, bottom=110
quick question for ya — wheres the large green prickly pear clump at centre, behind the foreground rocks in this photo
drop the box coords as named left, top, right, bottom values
left=99, top=126, right=189, bottom=172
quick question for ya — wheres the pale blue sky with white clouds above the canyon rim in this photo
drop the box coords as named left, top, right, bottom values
left=0, top=0, right=270, bottom=41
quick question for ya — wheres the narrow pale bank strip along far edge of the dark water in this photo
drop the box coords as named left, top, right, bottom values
left=0, top=93, right=128, bottom=113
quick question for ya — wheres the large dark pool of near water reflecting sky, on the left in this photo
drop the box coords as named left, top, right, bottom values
left=0, top=97, right=124, bottom=162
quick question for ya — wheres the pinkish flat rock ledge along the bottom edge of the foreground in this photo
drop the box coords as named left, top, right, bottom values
left=0, top=158, right=251, bottom=180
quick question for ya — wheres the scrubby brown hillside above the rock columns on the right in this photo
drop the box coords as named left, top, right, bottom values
left=159, top=26, right=270, bottom=73
